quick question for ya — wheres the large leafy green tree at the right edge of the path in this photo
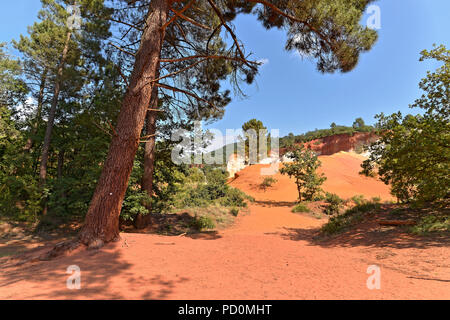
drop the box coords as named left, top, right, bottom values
left=362, top=46, right=450, bottom=202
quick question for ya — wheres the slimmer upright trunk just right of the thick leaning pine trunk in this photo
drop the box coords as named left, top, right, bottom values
left=135, top=86, right=159, bottom=229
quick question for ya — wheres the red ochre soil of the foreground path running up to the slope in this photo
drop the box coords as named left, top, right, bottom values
left=0, top=155, right=450, bottom=300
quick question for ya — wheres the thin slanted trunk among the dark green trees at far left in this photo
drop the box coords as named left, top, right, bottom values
left=39, top=31, right=72, bottom=188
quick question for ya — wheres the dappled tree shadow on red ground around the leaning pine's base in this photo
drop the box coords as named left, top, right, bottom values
left=0, top=243, right=189, bottom=299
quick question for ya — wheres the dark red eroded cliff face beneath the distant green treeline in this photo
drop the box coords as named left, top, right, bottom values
left=305, top=132, right=379, bottom=156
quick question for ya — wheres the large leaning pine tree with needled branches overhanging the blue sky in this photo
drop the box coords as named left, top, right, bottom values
left=81, top=0, right=377, bottom=247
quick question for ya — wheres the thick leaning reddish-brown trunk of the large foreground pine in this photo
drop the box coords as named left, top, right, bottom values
left=80, top=0, right=169, bottom=248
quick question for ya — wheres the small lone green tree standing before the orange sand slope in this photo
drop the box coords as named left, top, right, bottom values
left=280, top=146, right=326, bottom=201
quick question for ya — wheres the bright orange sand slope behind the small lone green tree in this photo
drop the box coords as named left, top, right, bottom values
left=231, top=152, right=393, bottom=202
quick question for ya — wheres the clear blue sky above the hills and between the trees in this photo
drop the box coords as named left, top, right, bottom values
left=0, top=0, right=450, bottom=140
